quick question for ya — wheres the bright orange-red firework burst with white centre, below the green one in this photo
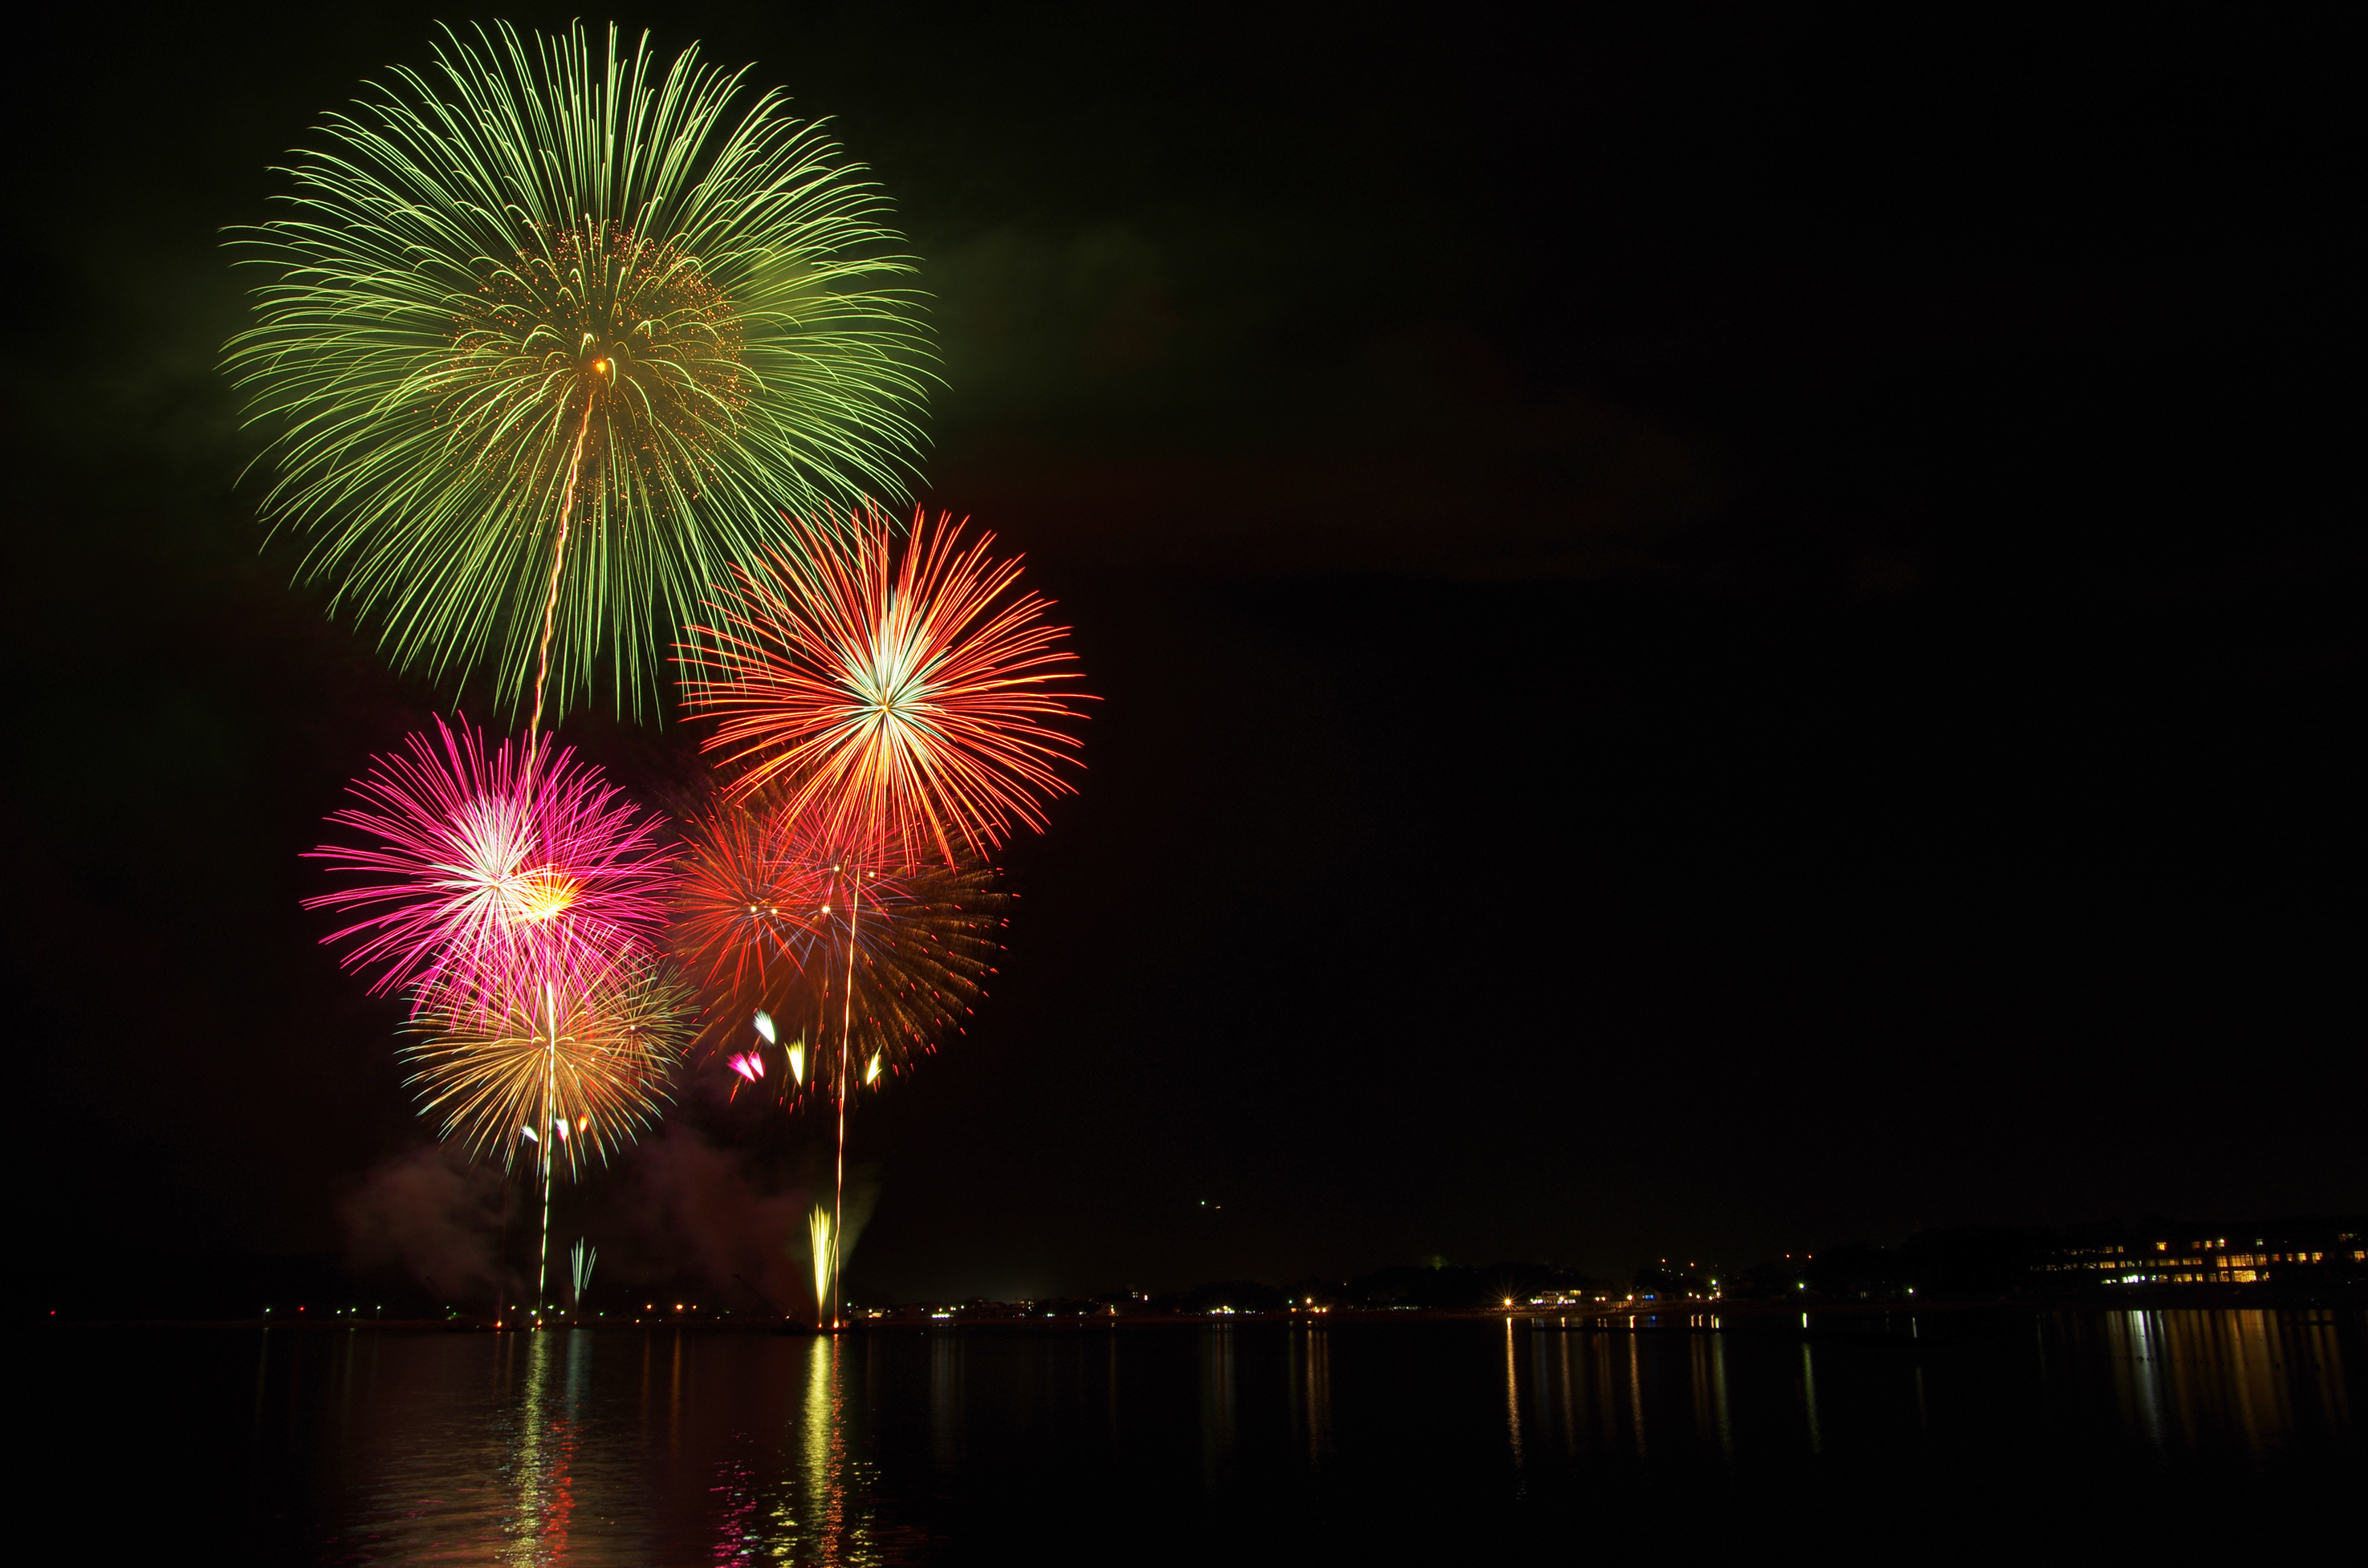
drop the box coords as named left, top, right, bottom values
left=680, top=512, right=1082, bottom=867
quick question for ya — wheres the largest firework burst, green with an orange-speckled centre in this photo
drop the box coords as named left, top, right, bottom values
left=225, top=24, right=926, bottom=710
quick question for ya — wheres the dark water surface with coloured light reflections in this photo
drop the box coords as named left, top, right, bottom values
left=19, top=1310, right=2368, bottom=1563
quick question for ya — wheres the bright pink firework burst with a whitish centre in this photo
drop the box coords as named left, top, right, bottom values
left=306, top=720, right=673, bottom=1000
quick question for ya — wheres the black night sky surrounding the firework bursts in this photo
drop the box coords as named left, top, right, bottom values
left=0, top=5, right=2368, bottom=1296
